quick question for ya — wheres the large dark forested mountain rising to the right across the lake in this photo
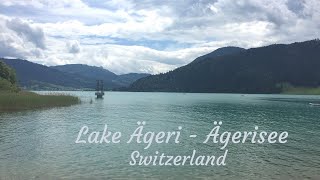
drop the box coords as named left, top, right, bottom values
left=127, top=40, right=320, bottom=93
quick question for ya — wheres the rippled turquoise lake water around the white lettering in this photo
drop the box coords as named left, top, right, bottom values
left=0, top=92, right=320, bottom=180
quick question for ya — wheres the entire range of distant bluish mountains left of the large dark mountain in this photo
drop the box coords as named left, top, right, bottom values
left=0, top=58, right=149, bottom=90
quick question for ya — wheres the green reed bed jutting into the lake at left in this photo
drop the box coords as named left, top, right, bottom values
left=0, top=91, right=80, bottom=112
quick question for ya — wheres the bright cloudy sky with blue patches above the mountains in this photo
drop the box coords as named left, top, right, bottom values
left=0, top=0, right=320, bottom=74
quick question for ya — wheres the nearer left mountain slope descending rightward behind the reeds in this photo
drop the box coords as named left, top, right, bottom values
left=0, top=58, right=95, bottom=90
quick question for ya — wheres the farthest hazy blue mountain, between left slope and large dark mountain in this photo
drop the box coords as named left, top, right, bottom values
left=51, top=64, right=150, bottom=87
